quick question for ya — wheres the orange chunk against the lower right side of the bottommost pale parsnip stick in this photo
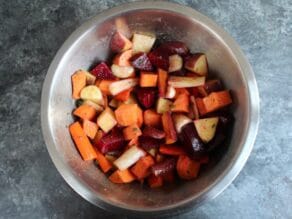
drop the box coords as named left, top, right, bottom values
left=131, top=155, right=154, bottom=180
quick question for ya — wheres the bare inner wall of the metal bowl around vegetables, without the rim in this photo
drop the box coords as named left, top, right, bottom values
left=45, top=9, right=249, bottom=211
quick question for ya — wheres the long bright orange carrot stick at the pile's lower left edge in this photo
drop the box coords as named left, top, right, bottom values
left=69, top=122, right=97, bottom=160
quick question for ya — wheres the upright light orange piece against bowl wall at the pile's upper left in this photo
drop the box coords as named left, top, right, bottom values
left=71, top=70, right=86, bottom=100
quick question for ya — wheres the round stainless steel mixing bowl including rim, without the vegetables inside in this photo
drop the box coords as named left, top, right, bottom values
left=41, top=1, right=259, bottom=216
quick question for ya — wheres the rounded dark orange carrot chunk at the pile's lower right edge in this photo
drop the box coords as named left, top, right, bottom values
left=176, top=155, right=200, bottom=180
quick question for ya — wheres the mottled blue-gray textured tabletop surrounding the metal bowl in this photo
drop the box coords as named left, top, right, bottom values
left=0, top=0, right=292, bottom=218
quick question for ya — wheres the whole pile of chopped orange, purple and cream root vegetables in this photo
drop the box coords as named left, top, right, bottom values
left=69, top=27, right=232, bottom=188
